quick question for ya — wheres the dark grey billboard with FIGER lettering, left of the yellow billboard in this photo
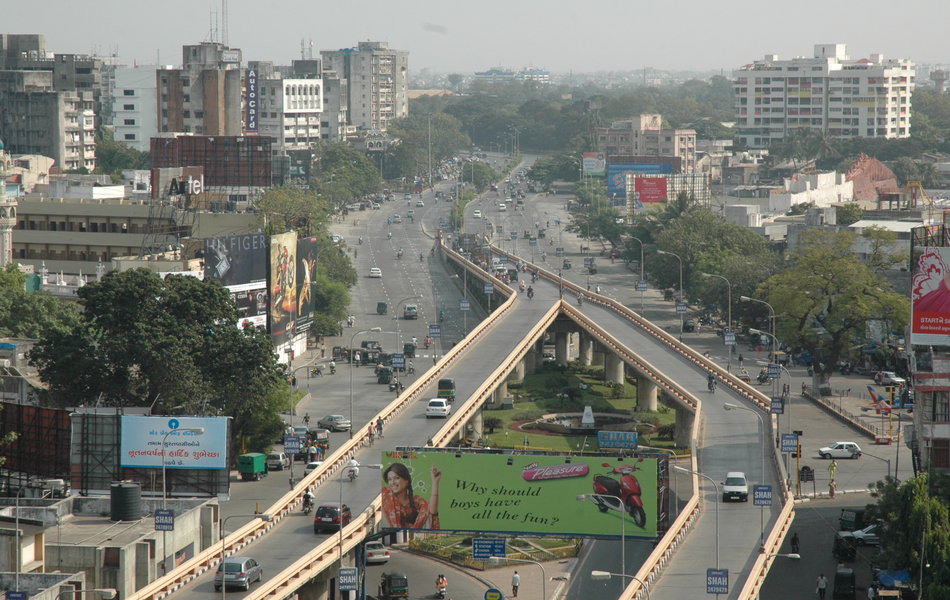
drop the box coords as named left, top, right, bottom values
left=203, top=233, right=267, bottom=287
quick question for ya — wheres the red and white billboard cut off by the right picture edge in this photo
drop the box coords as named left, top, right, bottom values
left=910, top=246, right=950, bottom=346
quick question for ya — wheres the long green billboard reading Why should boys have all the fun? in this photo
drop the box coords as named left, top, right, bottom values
left=382, top=451, right=658, bottom=539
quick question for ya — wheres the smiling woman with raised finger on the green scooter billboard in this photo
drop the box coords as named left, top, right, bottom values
left=383, top=463, right=442, bottom=529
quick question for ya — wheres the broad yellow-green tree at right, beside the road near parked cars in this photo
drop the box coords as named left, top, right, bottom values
left=756, top=229, right=910, bottom=381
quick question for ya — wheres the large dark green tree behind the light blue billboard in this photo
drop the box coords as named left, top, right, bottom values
left=29, top=269, right=290, bottom=448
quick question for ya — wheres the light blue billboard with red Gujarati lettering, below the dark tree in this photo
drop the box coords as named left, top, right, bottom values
left=119, top=415, right=228, bottom=469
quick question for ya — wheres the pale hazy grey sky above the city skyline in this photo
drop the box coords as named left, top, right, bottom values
left=7, top=0, right=950, bottom=73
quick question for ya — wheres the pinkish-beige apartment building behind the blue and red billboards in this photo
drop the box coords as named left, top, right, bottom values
left=595, top=114, right=696, bottom=172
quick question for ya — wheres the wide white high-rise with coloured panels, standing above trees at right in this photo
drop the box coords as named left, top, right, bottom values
left=733, top=44, right=915, bottom=148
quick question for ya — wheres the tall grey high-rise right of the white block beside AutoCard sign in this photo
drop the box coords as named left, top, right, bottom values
left=320, top=42, right=409, bottom=131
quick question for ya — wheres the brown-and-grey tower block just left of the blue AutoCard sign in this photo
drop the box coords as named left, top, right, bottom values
left=156, top=42, right=244, bottom=136
